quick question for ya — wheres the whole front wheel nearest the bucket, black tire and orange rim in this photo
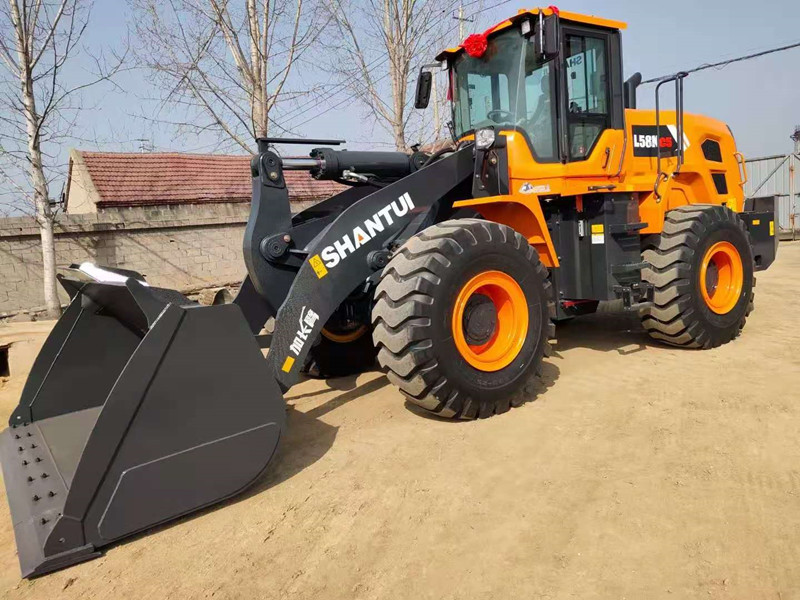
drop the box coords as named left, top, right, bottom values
left=372, top=219, right=555, bottom=419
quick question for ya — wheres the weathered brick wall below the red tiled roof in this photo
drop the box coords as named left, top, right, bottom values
left=0, top=203, right=316, bottom=316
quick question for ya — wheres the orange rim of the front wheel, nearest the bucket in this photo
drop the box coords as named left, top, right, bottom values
left=452, top=271, right=528, bottom=371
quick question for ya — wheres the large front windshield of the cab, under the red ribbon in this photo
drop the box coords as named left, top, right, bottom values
left=452, top=28, right=557, bottom=161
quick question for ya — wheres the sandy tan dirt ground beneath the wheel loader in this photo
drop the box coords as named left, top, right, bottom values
left=0, top=243, right=800, bottom=600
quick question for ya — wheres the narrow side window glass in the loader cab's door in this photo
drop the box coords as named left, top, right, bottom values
left=564, top=33, right=609, bottom=160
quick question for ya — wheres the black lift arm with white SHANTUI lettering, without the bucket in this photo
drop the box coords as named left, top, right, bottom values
left=235, top=145, right=474, bottom=391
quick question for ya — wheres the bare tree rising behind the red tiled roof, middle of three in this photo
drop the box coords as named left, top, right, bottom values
left=130, top=0, right=321, bottom=152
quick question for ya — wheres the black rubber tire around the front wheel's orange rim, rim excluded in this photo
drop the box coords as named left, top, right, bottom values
left=372, top=219, right=555, bottom=419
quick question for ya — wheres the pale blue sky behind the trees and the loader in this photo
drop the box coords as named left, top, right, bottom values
left=29, top=0, right=800, bottom=162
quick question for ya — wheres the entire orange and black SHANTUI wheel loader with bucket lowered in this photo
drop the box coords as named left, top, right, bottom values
left=0, top=7, right=777, bottom=577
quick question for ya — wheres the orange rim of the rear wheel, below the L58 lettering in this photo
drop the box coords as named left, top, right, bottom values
left=700, top=242, right=744, bottom=315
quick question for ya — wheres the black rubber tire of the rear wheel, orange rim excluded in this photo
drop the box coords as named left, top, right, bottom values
left=639, top=204, right=755, bottom=348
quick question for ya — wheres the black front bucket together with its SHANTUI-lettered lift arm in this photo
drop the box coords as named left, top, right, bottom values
left=0, top=139, right=474, bottom=577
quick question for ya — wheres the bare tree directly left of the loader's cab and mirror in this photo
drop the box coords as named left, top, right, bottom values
left=325, top=0, right=455, bottom=151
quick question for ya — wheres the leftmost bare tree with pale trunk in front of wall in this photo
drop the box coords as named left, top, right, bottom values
left=0, top=0, right=124, bottom=317
